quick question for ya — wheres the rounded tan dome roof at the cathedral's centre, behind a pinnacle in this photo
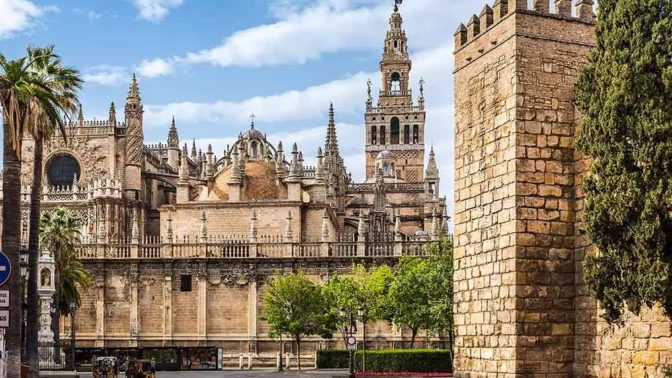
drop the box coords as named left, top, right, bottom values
left=207, top=160, right=283, bottom=201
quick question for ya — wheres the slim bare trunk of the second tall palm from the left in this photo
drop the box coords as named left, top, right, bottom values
left=26, top=130, right=44, bottom=378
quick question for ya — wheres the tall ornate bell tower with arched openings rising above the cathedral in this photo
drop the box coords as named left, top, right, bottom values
left=365, top=8, right=425, bottom=182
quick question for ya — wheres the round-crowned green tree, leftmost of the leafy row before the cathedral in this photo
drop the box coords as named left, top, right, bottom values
left=262, top=272, right=336, bottom=370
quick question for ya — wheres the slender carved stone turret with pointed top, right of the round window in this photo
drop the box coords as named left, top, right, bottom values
left=124, top=74, right=144, bottom=200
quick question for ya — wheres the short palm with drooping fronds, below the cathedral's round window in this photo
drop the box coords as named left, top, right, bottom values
left=40, top=208, right=93, bottom=362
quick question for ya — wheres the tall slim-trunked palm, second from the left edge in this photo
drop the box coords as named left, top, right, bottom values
left=26, top=46, right=82, bottom=378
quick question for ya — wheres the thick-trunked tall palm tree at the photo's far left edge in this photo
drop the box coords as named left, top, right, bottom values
left=0, top=48, right=64, bottom=378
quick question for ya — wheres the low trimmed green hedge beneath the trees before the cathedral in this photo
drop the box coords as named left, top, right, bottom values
left=317, top=349, right=453, bottom=373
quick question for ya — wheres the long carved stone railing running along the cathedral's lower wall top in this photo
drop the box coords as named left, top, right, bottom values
left=76, top=235, right=436, bottom=260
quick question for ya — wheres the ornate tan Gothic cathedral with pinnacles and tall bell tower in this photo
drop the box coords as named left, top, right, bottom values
left=7, top=5, right=448, bottom=369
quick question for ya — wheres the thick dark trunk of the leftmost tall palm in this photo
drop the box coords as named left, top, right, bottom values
left=2, top=120, right=23, bottom=378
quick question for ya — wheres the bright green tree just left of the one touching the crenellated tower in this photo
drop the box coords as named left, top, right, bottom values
left=389, top=256, right=433, bottom=348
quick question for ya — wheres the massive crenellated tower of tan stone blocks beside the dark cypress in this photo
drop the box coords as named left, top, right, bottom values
left=455, top=0, right=596, bottom=377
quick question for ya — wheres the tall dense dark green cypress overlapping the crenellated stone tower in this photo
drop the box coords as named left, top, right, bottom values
left=575, top=0, right=672, bottom=323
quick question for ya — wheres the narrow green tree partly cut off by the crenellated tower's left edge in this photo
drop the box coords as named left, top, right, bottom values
left=426, top=235, right=454, bottom=355
